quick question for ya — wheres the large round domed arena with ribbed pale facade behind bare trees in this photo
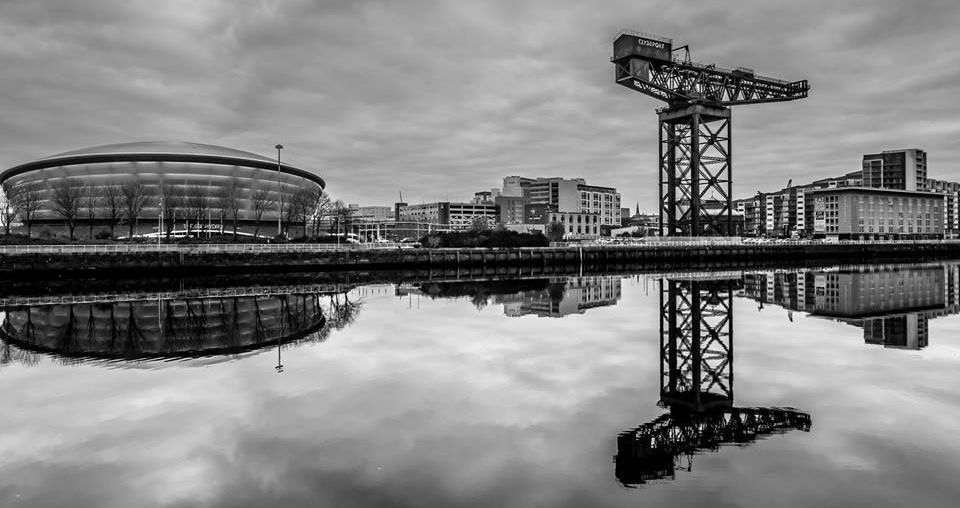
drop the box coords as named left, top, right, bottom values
left=0, top=141, right=326, bottom=238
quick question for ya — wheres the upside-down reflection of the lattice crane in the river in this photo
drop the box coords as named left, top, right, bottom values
left=614, top=275, right=810, bottom=486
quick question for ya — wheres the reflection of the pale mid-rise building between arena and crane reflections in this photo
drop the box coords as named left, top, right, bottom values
left=494, top=275, right=620, bottom=317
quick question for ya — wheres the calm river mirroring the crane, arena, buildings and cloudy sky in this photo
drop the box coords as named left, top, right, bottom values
left=0, top=263, right=960, bottom=507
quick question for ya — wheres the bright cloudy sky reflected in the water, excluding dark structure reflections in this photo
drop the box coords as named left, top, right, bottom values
left=0, top=282, right=960, bottom=506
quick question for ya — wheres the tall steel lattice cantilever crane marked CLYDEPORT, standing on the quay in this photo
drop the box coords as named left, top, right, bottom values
left=611, top=33, right=810, bottom=236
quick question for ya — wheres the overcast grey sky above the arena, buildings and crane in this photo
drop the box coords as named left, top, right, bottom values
left=0, top=0, right=960, bottom=211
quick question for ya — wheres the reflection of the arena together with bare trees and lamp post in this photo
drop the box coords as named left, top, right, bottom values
left=0, top=287, right=362, bottom=371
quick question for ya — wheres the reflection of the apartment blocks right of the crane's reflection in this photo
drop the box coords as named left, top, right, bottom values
left=742, top=264, right=960, bottom=349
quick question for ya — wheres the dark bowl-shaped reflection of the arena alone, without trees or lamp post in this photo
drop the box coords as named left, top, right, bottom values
left=0, top=294, right=326, bottom=359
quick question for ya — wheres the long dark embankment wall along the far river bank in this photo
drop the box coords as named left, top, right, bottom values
left=0, top=242, right=960, bottom=278
